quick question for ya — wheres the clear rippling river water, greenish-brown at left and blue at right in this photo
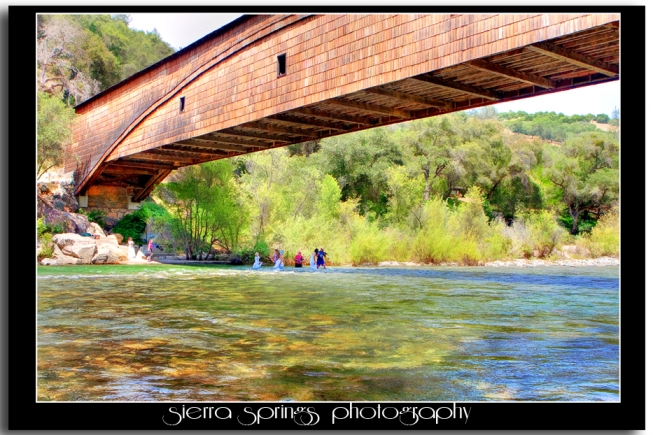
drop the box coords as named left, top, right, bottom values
left=38, top=265, right=619, bottom=401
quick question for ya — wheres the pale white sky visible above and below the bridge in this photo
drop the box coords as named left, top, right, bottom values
left=129, top=12, right=621, bottom=116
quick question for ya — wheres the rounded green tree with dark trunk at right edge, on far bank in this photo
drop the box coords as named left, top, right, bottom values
left=547, top=133, right=619, bottom=234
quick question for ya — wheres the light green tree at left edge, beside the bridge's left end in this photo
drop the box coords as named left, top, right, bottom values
left=36, top=92, right=75, bottom=180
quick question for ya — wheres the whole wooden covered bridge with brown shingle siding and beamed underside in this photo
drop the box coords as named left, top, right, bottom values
left=66, top=14, right=619, bottom=202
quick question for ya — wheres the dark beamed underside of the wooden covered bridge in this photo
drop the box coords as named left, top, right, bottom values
left=78, top=18, right=619, bottom=202
